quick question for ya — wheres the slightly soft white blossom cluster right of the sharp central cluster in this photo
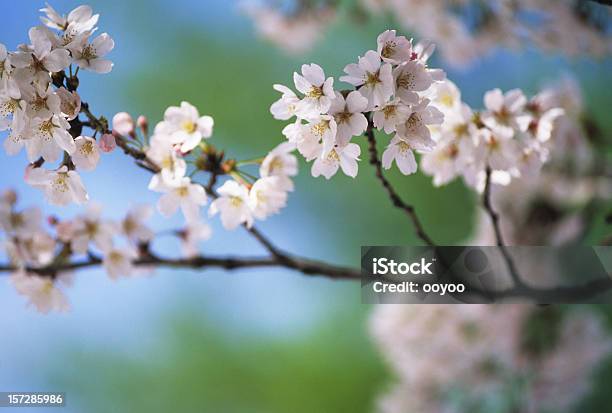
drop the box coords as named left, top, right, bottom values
left=421, top=79, right=564, bottom=191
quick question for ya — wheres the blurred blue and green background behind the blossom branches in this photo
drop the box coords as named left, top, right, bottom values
left=0, top=0, right=612, bottom=413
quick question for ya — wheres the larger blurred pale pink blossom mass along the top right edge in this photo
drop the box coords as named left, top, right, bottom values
left=363, top=0, right=612, bottom=66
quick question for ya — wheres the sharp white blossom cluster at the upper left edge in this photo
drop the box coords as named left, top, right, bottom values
left=0, top=5, right=114, bottom=205
